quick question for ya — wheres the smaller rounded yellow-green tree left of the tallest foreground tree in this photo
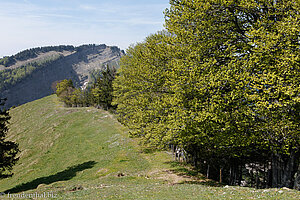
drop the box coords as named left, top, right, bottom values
left=114, top=33, right=176, bottom=145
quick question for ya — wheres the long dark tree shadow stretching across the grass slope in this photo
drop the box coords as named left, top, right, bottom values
left=4, top=161, right=97, bottom=194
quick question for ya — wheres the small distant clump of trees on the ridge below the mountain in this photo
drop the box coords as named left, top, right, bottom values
left=55, top=66, right=116, bottom=110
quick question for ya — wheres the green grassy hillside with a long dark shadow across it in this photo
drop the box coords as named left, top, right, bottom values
left=0, top=95, right=300, bottom=199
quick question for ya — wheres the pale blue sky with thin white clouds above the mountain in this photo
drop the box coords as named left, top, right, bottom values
left=0, top=0, right=169, bottom=57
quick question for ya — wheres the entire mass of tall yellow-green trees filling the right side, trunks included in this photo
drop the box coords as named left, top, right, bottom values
left=114, top=0, right=300, bottom=188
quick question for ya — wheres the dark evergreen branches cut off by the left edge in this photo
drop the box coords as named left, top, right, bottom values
left=0, top=99, right=19, bottom=179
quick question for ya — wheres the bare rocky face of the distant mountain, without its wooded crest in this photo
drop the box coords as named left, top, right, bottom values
left=0, top=45, right=124, bottom=107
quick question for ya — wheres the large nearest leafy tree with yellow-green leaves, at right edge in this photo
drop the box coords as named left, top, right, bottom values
left=166, top=0, right=300, bottom=187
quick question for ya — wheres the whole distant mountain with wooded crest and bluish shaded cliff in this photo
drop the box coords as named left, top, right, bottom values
left=0, top=44, right=124, bottom=107
